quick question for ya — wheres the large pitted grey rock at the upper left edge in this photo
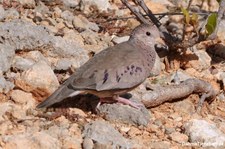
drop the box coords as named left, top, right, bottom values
left=0, top=19, right=52, bottom=51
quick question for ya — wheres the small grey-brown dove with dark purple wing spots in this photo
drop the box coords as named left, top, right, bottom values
left=37, top=24, right=160, bottom=108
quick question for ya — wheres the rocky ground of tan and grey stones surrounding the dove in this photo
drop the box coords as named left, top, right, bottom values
left=0, top=0, right=225, bottom=149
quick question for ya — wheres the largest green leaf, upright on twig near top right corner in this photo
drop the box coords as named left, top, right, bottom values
left=205, top=13, right=217, bottom=35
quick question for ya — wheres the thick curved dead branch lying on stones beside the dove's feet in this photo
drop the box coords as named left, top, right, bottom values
left=142, top=78, right=216, bottom=110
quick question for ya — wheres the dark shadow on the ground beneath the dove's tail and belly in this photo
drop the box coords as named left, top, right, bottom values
left=51, top=93, right=132, bottom=112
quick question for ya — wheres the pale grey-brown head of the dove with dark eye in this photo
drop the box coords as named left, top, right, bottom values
left=130, top=24, right=160, bottom=46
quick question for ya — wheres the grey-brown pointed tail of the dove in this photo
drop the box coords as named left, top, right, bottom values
left=37, top=84, right=82, bottom=108
